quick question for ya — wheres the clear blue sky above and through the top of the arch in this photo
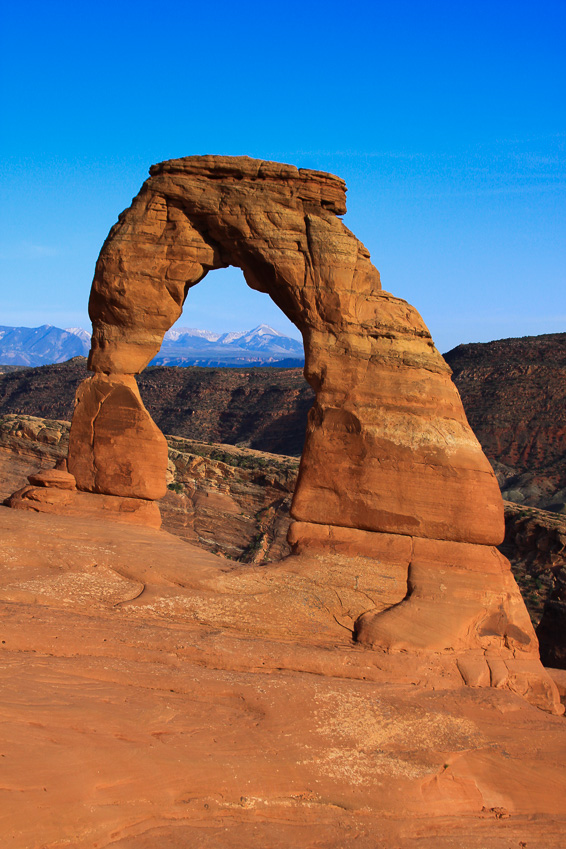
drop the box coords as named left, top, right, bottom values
left=0, top=0, right=566, bottom=351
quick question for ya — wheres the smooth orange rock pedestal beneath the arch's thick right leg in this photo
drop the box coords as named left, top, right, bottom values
left=289, top=522, right=564, bottom=716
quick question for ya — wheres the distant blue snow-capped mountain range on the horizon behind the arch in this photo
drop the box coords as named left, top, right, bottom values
left=0, top=324, right=304, bottom=367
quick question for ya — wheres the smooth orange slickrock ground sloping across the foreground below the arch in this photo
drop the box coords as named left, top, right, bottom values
left=0, top=507, right=566, bottom=849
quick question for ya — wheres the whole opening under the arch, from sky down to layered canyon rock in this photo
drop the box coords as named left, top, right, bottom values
left=137, top=268, right=314, bottom=565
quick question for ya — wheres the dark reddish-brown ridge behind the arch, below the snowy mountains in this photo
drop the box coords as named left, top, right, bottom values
left=0, top=333, right=566, bottom=504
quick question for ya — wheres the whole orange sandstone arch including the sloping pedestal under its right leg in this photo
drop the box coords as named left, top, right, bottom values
left=7, top=156, right=560, bottom=711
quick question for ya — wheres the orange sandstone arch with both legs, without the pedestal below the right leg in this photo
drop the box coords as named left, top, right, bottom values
left=69, top=156, right=503, bottom=544
